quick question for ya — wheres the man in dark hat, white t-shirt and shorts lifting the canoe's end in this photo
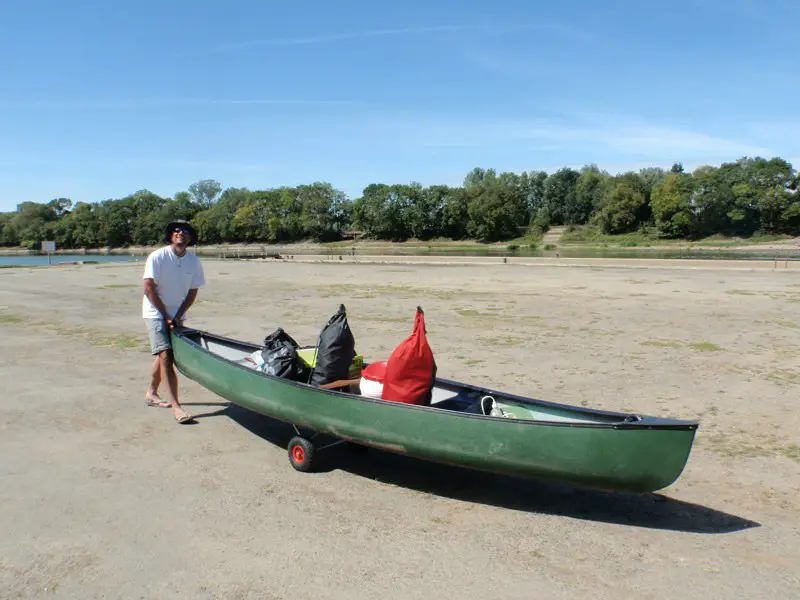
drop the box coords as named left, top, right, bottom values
left=142, top=221, right=206, bottom=423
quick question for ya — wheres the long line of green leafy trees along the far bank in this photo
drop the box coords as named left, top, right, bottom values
left=0, top=157, right=800, bottom=248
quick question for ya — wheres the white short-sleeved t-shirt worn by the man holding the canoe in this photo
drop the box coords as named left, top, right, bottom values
left=142, top=246, right=206, bottom=319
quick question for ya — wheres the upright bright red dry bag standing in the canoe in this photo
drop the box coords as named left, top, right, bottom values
left=381, top=306, right=436, bottom=405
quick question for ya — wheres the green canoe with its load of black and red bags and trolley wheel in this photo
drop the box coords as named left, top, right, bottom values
left=172, top=305, right=698, bottom=492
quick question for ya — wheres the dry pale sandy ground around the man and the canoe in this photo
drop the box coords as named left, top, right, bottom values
left=0, top=260, right=800, bottom=600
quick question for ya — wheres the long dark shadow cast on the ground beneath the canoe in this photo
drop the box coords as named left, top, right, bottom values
left=224, top=405, right=761, bottom=533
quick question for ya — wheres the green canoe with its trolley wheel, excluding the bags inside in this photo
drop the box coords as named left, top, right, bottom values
left=172, top=328, right=697, bottom=492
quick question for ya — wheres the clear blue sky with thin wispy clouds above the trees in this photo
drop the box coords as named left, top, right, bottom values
left=0, top=0, right=800, bottom=211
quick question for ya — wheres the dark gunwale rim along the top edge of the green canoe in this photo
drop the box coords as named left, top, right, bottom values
left=171, top=327, right=698, bottom=431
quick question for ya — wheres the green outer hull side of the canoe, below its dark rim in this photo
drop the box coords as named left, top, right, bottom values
left=173, top=334, right=696, bottom=492
